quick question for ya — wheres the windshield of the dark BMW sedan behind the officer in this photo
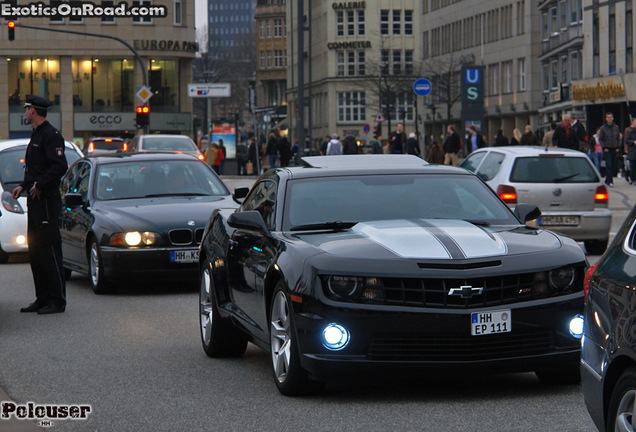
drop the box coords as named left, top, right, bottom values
left=95, top=160, right=229, bottom=200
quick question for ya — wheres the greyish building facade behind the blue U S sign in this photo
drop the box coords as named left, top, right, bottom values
left=419, top=0, right=543, bottom=145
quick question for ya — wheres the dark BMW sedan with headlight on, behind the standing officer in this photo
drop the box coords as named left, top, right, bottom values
left=60, top=153, right=243, bottom=294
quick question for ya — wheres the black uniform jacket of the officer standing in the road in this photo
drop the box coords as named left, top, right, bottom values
left=20, top=121, right=68, bottom=196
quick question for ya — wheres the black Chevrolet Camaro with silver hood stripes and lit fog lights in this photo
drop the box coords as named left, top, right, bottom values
left=199, top=155, right=586, bottom=395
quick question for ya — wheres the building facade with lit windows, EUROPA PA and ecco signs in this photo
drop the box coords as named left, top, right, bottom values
left=0, top=0, right=198, bottom=145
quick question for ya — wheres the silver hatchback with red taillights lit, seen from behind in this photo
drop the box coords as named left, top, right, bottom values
left=461, top=146, right=612, bottom=255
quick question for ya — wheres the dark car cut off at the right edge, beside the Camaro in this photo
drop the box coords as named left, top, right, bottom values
left=581, top=207, right=636, bottom=432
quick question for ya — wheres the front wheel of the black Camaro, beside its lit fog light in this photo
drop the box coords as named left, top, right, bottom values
left=269, top=280, right=326, bottom=396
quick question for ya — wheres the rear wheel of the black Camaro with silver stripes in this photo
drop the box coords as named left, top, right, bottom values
left=199, top=260, right=247, bottom=358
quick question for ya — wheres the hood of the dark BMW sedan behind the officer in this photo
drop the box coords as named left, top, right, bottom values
left=93, top=196, right=238, bottom=231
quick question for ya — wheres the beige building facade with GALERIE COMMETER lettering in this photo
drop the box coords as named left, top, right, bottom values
left=286, top=0, right=421, bottom=147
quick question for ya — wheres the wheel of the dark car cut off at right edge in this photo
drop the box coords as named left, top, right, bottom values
left=605, top=366, right=636, bottom=432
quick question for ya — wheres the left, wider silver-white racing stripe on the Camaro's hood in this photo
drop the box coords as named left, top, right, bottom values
left=352, top=220, right=451, bottom=259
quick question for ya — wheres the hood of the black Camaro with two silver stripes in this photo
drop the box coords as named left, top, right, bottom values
left=295, top=219, right=562, bottom=260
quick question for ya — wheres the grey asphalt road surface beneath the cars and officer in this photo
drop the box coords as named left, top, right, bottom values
left=0, top=177, right=636, bottom=432
